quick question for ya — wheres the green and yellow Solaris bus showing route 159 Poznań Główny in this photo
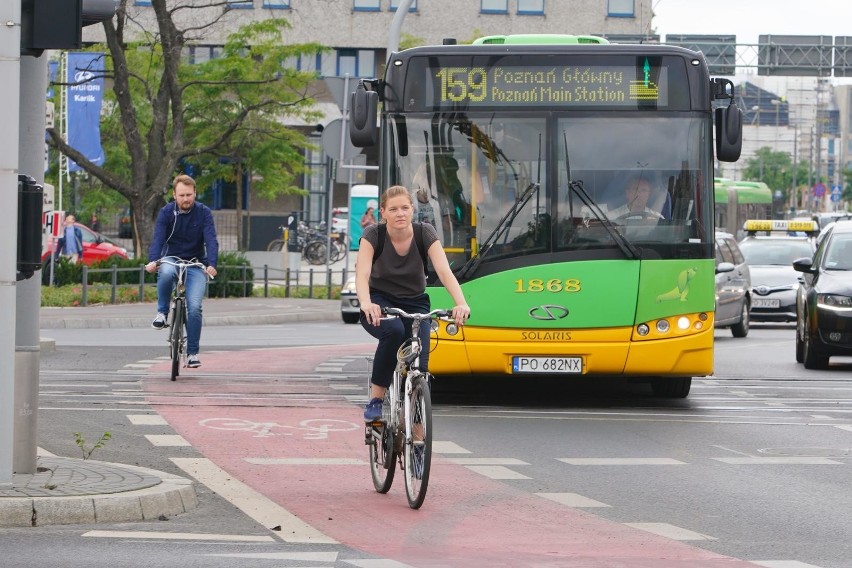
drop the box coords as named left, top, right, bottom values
left=349, top=35, right=742, bottom=397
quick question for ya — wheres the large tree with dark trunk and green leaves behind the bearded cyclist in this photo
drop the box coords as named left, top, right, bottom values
left=48, top=0, right=323, bottom=255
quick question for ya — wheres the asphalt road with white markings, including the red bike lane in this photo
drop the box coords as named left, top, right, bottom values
left=2, top=322, right=852, bottom=568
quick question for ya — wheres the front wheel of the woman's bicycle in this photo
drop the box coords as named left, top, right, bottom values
left=404, top=374, right=432, bottom=509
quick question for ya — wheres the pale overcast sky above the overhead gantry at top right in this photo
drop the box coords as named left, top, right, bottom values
left=652, top=0, right=852, bottom=44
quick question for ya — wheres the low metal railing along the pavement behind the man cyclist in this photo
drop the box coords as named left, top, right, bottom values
left=72, top=264, right=351, bottom=306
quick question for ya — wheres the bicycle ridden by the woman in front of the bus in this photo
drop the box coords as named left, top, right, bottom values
left=364, top=308, right=458, bottom=509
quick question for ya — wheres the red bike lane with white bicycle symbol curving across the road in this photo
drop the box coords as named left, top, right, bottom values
left=143, top=345, right=755, bottom=568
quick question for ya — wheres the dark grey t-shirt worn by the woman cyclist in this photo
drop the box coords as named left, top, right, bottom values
left=361, top=223, right=438, bottom=298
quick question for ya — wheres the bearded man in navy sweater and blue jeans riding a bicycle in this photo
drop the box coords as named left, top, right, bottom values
left=145, top=175, right=219, bottom=368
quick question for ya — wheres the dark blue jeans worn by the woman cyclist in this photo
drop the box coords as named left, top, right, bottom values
left=360, top=292, right=431, bottom=388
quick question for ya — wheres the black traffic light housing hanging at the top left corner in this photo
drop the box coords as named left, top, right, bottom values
left=21, top=0, right=116, bottom=57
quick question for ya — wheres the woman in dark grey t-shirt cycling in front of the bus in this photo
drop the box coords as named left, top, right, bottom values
left=355, top=185, right=470, bottom=422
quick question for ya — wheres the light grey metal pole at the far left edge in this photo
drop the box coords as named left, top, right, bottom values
left=0, top=2, right=23, bottom=488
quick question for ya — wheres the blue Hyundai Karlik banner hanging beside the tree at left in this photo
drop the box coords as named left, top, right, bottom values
left=66, top=52, right=104, bottom=172
